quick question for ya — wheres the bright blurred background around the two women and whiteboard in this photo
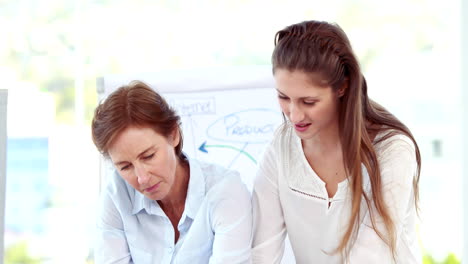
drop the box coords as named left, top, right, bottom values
left=0, top=0, right=463, bottom=264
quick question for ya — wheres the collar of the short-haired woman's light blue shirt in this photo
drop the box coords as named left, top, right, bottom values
left=132, top=155, right=205, bottom=219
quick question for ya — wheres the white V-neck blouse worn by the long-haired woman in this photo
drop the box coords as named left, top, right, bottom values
left=252, top=125, right=422, bottom=264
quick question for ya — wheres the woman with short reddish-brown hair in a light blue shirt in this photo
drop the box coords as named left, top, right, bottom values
left=92, top=81, right=252, bottom=264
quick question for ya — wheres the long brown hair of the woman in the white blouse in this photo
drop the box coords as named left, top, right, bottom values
left=272, top=21, right=421, bottom=257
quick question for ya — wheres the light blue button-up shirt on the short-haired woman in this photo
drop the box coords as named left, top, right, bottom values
left=94, top=156, right=252, bottom=264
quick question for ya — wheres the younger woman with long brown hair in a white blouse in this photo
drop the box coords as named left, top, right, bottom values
left=252, top=21, right=422, bottom=264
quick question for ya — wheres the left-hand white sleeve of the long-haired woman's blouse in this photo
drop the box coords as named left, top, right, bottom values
left=252, top=145, right=286, bottom=264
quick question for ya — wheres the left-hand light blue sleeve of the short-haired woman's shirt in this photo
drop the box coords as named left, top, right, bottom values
left=94, top=190, right=133, bottom=264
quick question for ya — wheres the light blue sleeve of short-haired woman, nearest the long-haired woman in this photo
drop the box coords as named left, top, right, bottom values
left=209, top=173, right=252, bottom=264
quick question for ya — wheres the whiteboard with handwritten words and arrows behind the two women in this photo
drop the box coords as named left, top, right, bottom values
left=97, top=66, right=295, bottom=263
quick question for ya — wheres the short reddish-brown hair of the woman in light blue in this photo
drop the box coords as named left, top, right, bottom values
left=91, top=81, right=184, bottom=160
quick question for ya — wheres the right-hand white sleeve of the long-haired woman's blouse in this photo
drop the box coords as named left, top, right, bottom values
left=349, top=135, right=422, bottom=264
